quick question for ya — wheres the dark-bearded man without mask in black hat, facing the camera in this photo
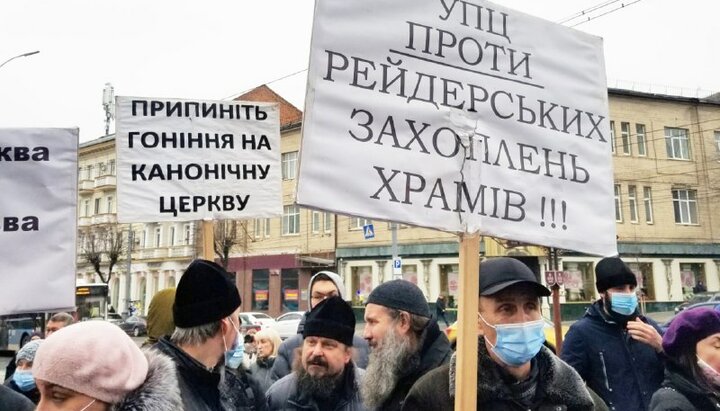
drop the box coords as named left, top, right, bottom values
left=266, top=297, right=366, bottom=411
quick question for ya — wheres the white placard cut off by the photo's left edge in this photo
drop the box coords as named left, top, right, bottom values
left=0, top=128, right=78, bottom=315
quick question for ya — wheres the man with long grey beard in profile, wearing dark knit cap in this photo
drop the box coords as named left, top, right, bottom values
left=360, top=280, right=452, bottom=410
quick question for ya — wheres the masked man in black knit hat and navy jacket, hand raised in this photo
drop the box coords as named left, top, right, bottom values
left=561, top=257, right=665, bottom=411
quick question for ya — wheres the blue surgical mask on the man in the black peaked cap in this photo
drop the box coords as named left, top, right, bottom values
left=478, top=313, right=545, bottom=367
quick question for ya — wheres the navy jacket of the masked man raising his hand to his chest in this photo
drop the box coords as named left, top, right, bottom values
left=560, top=300, right=665, bottom=411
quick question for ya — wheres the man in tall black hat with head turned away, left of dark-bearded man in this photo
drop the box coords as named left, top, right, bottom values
left=155, top=260, right=265, bottom=411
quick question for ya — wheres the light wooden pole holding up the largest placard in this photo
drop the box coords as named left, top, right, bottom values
left=455, top=234, right=480, bottom=411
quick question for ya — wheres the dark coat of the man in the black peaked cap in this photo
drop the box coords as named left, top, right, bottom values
left=403, top=337, right=607, bottom=411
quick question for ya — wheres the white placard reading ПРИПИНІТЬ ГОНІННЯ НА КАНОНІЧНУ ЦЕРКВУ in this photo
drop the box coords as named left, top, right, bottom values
left=116, top=97, right=282, bottom=223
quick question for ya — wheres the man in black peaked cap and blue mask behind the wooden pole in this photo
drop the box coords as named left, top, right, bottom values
left=403, top=257, right=606, bottom=411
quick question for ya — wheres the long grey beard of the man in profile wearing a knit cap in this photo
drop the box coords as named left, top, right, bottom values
left=360, top=330, right=420, bottom=408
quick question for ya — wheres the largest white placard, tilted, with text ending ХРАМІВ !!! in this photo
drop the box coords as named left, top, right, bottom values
left=297, top=0, right=616, bottom=255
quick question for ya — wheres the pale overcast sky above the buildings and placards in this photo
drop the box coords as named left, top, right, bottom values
left=0, top=0, right=720, bottom=142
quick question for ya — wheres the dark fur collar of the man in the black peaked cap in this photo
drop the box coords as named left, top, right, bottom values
left=449, top=337, right=593, bottom=409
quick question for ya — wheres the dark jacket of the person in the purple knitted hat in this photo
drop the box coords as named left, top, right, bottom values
left=650, top=362, right=720, bottom=411
